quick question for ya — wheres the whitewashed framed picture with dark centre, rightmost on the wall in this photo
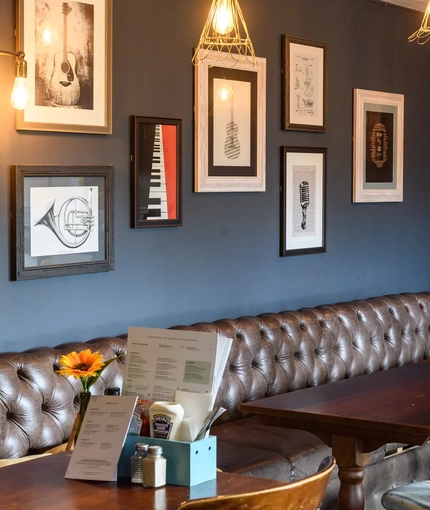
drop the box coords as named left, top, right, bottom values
left=352, top=89, right=404, bottom=202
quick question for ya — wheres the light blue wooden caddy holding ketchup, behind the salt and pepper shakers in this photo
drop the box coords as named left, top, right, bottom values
left=118, top=435, right=216, bottom=487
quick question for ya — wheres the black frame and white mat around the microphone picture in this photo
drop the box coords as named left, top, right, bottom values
left=280, top=147, right=327, bottom=257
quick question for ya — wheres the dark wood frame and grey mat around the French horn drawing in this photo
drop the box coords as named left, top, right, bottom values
left=11, top=165, right=114, bottom=280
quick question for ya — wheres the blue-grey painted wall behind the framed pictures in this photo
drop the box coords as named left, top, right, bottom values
left=0, top=0, right=430, bottom=351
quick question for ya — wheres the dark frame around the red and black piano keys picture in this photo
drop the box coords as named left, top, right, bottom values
left=130, top=115, right=182, bottom=228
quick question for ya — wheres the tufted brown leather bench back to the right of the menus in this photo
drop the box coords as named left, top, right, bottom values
left=176, top=292, right=430, bottom=423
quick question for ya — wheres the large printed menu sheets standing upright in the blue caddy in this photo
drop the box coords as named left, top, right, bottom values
left=123, top=327, right=232, bottom=402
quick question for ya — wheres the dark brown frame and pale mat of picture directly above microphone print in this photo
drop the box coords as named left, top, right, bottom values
left=282, top=35, right=327, bottom=133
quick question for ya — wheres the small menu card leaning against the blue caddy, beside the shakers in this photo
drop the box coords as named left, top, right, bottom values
left=65, top=395, right=137, bottom=481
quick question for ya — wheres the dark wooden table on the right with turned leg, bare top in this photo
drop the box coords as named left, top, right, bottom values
left=239, top=361, right=430, bottom=510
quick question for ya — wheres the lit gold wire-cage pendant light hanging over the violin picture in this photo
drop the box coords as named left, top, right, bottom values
left=192, top=0, right=255, bottom=67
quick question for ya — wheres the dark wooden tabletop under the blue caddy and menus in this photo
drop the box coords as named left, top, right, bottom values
left=0, top=452, right=283, bottom=510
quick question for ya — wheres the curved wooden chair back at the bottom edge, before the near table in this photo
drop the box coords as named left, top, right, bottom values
left=176, top=457, right=336, bottom=510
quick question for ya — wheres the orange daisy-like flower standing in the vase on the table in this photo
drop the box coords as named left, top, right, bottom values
left=57, top=349, right=122, bottom=391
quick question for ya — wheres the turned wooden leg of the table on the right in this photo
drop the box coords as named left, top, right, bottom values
left=332, top=435, right=370, bottom=510
